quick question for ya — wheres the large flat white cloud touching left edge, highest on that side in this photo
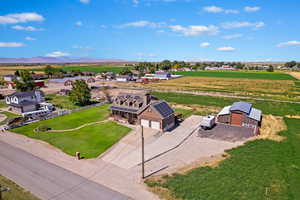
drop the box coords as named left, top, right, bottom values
left=0, top=13, right=45, bottom=24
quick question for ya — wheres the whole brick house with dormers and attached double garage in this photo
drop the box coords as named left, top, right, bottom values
left=110, top=94, right=175, bottom=131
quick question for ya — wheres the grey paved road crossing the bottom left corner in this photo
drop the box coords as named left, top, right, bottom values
left=0, top=141, right=130, bottom=200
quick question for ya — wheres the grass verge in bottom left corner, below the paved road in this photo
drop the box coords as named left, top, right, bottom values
left=0, top=175, right=38, bottom=200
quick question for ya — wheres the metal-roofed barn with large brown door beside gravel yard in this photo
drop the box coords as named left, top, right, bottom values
left=217, top=102, right=262, bottom=131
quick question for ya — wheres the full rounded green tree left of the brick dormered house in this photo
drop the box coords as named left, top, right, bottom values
left=70, top=80, right=91, bottom=106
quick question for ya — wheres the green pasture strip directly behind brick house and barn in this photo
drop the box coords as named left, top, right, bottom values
left=152, top=92, right=300, bottom=116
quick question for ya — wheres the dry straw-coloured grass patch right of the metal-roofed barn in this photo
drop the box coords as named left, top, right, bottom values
left=258, top=115, right=287, bottom=141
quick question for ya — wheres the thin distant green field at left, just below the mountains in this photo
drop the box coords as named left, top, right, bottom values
left=32, top=65, right=130, bottom=73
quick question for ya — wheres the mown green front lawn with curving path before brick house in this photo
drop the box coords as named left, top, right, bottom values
left=12, top=105, right=130, bottom=158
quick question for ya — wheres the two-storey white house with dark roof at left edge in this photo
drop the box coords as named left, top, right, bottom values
left=5, top=90, right=45, bottom=113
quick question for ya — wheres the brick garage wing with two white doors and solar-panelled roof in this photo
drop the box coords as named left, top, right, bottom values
left=138, top=101, right=175, bottom=132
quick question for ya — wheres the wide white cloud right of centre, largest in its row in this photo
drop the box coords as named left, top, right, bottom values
left=169, top=25, right=219, bottom=36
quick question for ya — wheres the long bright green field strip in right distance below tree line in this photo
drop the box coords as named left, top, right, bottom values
left=175, top=71, right=297, bottom=80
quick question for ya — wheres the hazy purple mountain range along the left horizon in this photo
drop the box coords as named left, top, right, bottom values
left=0, top=57, right=126, bottom=63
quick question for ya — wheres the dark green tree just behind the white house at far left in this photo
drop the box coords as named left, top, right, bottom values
left=13, top=70, right=36, bottom=92
